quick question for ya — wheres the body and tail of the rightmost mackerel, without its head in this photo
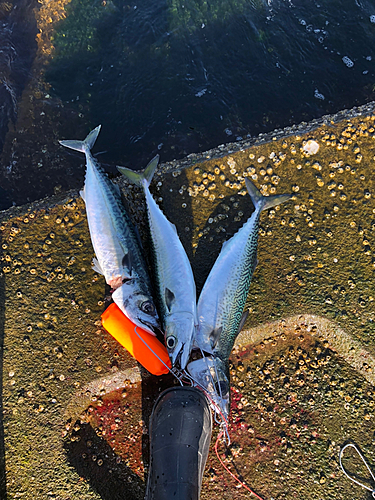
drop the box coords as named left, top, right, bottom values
left=195, top=178, right=291, bottom=360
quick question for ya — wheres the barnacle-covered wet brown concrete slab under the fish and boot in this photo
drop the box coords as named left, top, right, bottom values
left=0, top=105, right=375, bottom=500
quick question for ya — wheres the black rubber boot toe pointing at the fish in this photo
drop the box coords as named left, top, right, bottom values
left=145, top=387, right=212, bottom=500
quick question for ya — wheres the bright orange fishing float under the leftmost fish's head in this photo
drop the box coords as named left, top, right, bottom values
left=102, top=303, right=172, bottom=375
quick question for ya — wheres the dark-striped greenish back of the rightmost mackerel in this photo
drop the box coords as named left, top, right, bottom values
left=214, top=216, right=260, bottom=360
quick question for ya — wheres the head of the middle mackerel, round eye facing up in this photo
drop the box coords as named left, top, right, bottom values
left=165, top=312, right=195, bottom=370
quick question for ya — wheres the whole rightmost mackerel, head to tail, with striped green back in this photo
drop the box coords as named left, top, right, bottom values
left=187, top=179, right=291, bottom=423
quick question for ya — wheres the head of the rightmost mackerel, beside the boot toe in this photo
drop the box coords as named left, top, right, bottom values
left=187, top=356, right=230, bottom=421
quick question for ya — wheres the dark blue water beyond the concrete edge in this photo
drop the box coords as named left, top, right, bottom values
left=0, top=0, right=375, bottom=208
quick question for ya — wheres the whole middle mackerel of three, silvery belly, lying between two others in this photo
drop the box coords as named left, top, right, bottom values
left=117, top=156, right=198, bottom=369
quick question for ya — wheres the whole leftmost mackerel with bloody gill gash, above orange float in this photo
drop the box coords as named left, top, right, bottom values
left=59, top=125, right=160, bottom=335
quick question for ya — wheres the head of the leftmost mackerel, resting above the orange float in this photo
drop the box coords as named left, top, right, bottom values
left=112, top=280, right=160, bottom=335
